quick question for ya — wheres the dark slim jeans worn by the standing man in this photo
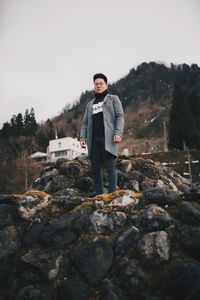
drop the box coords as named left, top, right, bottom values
left=90, top=137, right=117, bottom=195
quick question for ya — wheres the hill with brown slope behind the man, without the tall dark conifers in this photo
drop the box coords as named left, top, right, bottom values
left=52, top=62, right=200, bottom=154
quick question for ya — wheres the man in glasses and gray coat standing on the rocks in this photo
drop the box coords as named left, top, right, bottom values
left=80, top=73, right=124, bottom=195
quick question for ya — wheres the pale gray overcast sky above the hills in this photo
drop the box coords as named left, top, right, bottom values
left=0, top=0, right=200, bottom=126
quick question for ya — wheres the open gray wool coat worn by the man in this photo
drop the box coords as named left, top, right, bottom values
left=80, top=94, right=124, bottom=157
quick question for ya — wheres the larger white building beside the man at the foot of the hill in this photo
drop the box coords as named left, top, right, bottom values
left=47, top=137, right=87, bottom=161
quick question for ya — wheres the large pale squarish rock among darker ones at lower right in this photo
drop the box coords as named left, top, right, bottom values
left=138, top=231, right=170, bottom=264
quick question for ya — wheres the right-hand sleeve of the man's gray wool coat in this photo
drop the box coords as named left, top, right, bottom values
left=113, top=96, right=124, bottom=136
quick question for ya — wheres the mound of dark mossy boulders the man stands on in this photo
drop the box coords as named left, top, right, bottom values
left=0, top=157, right=200, bottom=300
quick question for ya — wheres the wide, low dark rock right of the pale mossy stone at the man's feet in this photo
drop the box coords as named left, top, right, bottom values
left=144, top=188, right=181, bottom=205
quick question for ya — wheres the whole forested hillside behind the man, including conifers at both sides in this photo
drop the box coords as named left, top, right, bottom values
left=0, top=62, right=200, bottom=193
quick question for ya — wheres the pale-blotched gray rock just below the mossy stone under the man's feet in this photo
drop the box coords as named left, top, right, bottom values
left=90, top=210, right=126, bottom=234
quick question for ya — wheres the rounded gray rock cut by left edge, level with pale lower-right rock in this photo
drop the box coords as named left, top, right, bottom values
left=0, top=226, right=21, bottom=260
